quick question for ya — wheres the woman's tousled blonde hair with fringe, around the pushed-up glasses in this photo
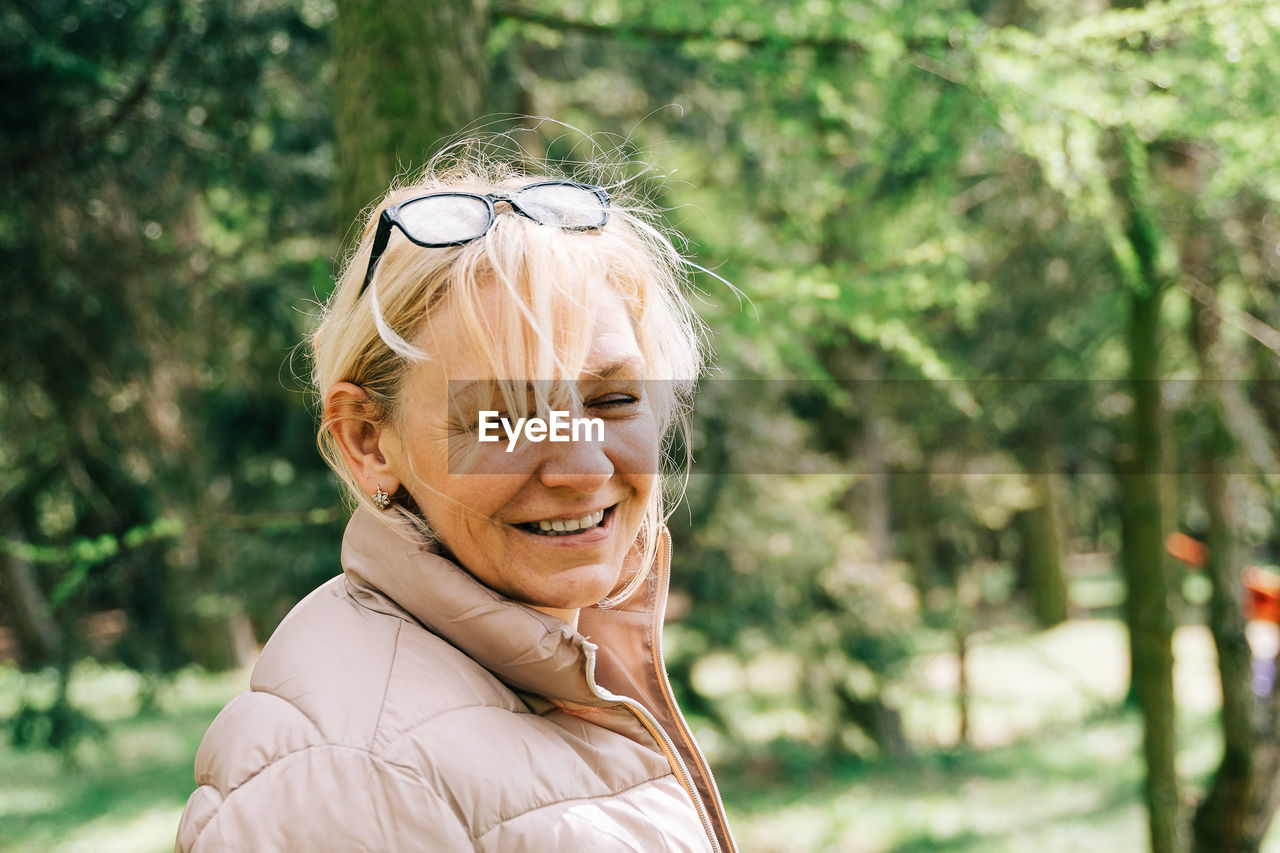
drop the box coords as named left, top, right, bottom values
left=310, top=141, right=704, bottom=606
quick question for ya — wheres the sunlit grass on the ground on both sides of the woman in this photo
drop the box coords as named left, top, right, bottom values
left=0, top=620, right=1280, bottom=853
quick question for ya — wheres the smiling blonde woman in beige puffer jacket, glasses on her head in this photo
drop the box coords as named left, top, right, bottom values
left=177, top=153, right=733, bottom=853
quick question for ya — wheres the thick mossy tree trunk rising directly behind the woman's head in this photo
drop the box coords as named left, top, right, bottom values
left=334, top=0, right=489, bottom=222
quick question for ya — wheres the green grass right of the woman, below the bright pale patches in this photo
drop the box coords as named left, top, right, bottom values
left=722, top=713, right=1172, bottom=853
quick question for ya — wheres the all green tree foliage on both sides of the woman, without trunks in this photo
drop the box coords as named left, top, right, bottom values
left=0, top=0, right=1280, bottom=829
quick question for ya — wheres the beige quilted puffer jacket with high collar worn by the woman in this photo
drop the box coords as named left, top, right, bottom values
left=175, top=510, right=735, bottom=853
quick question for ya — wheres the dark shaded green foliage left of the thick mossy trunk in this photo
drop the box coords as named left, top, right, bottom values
left=0, top=0, right=334, bottom=669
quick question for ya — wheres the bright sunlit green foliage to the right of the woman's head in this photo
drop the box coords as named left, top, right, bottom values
left=495, top=0, right=1280, bottom=778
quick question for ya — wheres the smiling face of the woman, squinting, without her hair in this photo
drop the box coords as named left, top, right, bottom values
left=385, top=280, right=659, bottom=621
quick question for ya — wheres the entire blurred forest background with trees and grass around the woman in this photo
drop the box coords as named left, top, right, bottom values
left=0, top=0, right=1280, bottom=853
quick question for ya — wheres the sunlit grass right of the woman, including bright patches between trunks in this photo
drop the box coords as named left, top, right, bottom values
left=724, top=620, right=1280, bottom=853
